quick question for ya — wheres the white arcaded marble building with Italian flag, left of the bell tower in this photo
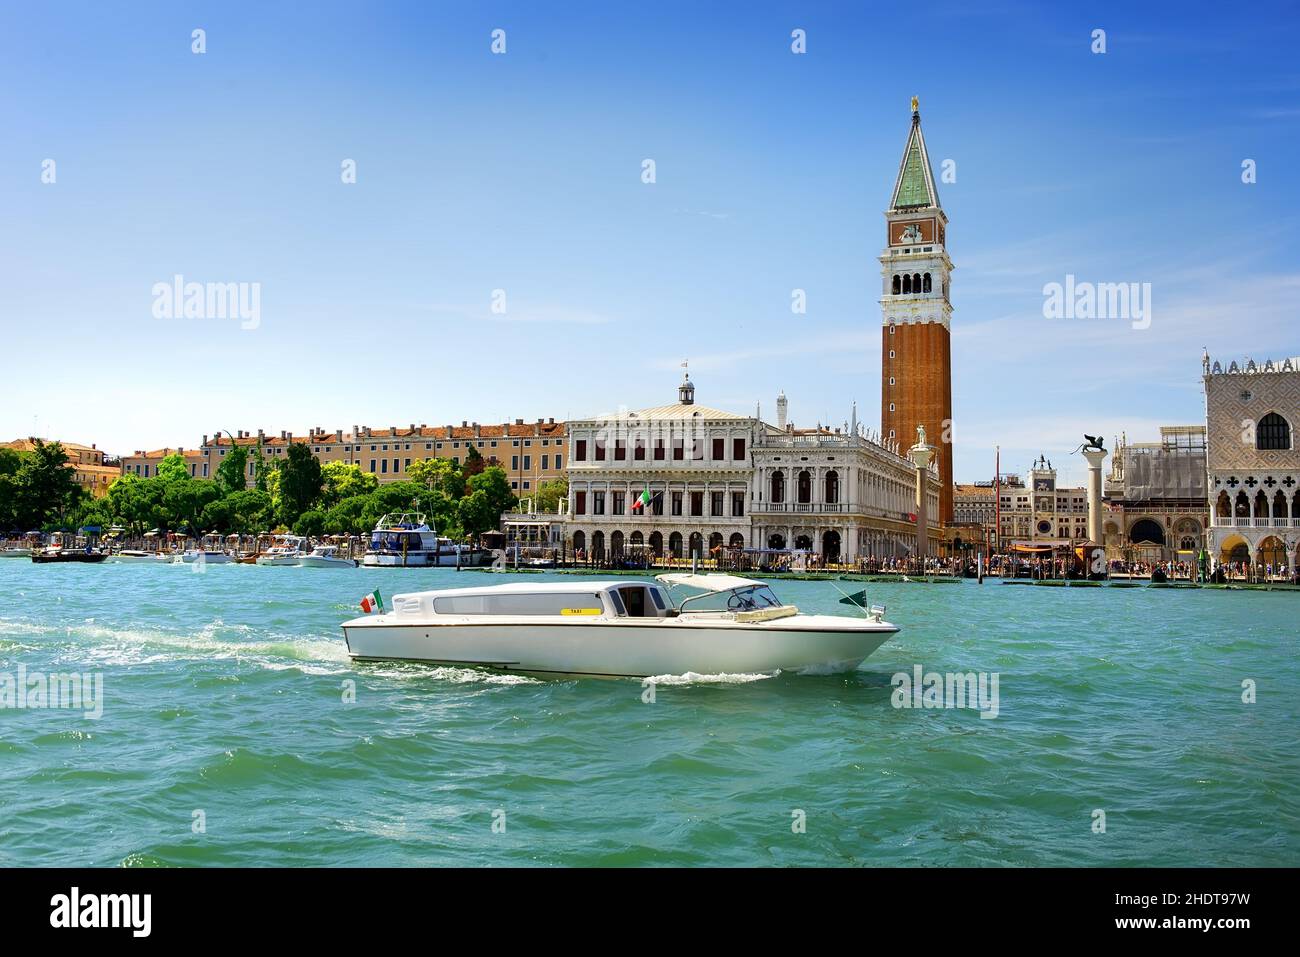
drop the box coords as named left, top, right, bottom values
left=564, top=376, right=940, bottom=562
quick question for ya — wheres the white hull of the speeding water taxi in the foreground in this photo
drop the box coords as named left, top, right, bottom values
left=343, top=612, right=898, bottom=677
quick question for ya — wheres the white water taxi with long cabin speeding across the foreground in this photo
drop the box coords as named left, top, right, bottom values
left=343, top=573, right=898, bottom=677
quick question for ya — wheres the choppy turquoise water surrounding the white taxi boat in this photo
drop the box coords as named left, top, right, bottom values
left=0, top=559, right=1300, bottom=866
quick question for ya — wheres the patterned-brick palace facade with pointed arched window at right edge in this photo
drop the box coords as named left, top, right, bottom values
left=1201, top=355, right=1300, bottom=568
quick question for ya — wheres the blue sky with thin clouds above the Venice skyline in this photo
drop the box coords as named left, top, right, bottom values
left=0, top=3, right=1300, bottom=481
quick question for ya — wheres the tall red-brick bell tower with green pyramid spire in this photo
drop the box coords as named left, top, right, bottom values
left=880, top=96, right=953, bottom=524
